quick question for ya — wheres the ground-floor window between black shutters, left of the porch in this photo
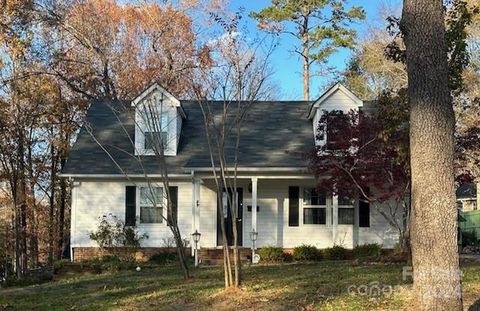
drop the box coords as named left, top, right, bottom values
left=140, top=187, right=163, bottom=224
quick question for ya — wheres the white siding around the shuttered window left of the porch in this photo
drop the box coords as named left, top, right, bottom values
left=71, top=180, right=192, bottom=247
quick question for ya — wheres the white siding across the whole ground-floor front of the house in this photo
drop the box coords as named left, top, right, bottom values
left=71, top=178, right=398, bottom=252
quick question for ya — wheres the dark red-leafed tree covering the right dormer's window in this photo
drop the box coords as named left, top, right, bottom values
left=308, top=100, right=410, bottom=252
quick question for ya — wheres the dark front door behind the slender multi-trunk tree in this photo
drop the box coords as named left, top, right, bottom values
left=217, top=188, right=243, bottom=246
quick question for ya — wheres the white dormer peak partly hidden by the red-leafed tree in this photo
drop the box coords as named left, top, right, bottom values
left=308, top=83, right=363, bottom=145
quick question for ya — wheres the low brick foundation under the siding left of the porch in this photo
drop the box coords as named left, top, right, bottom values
left=73, top=247, right=190, bottom=262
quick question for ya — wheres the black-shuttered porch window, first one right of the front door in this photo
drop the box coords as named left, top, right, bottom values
left=303, top=188, right=327, bottom=225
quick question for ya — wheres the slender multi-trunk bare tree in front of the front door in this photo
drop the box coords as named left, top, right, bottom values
left=192, top=14, right=276, bottom=288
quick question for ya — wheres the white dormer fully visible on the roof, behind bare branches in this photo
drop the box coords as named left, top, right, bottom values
left=131, top=83, right=187, bottom=156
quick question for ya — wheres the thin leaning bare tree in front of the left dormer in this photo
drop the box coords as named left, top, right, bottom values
left=83, top=94, right=190, bottom=279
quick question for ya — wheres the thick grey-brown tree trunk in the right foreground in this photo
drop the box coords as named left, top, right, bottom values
left=401, top=0, right=462, bottom=310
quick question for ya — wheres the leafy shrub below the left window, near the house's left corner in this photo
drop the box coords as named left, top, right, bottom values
left=90, top=214, right=148, bottom=262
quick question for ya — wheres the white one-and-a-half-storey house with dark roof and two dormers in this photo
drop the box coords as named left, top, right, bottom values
left=62, top=84, right=398, bottom=260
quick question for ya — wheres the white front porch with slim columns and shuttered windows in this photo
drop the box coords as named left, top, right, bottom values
left=191, top=172, right=390, bottom=255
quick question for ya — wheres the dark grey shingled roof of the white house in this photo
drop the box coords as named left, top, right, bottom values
left=62, top=101, right=313, bottom=175
